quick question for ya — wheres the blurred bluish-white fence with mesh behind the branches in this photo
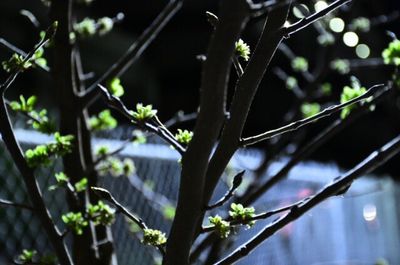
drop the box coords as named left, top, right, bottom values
left=0, top=130, right=400, bottom=265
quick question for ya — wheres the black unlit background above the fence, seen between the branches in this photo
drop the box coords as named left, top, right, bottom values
left=0, top=0, right=400, bottom=176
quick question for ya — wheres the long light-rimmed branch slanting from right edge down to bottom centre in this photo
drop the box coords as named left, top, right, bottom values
left=214, top=132, right=400, bottom=265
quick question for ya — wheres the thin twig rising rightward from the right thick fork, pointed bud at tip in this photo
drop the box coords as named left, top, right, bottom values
left=240, top=84, right=384, bottom=146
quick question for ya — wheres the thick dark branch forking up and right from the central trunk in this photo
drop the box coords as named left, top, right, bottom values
left=203, top=3, right=289, bottom=227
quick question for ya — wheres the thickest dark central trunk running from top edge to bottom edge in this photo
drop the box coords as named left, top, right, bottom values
left=164, top=0, right=249, bottom=265
